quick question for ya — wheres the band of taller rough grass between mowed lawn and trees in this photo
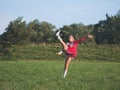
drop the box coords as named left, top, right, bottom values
left=0, top=44, right=120, bottom=61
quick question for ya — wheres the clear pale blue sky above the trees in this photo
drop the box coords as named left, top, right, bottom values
left=0, top=0, right=120, bottom=34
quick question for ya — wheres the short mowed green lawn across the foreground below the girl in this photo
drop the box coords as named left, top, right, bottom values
left=0, top=60, right=120, bottom=90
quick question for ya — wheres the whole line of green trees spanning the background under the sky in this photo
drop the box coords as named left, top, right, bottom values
left=0, top=10, right=120, bottom=52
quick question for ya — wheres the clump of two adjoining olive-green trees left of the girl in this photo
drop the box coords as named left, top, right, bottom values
left=1, top=17, right=55, bottom=44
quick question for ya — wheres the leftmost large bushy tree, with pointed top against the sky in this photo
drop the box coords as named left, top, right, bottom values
left=3, top=17, right=29, bottom=44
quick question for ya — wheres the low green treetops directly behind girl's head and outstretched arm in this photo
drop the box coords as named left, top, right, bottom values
left=60, top=23, right=93, bottom=41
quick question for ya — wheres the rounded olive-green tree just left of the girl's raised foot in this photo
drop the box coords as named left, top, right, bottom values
left=27, top=19, right=55, bottom=43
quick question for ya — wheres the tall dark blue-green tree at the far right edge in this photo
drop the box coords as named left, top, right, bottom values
left=93, top=11, right=120, bottom=44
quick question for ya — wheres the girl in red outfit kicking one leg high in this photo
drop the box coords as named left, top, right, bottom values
left=56, top=31, right=93, bottom=78
